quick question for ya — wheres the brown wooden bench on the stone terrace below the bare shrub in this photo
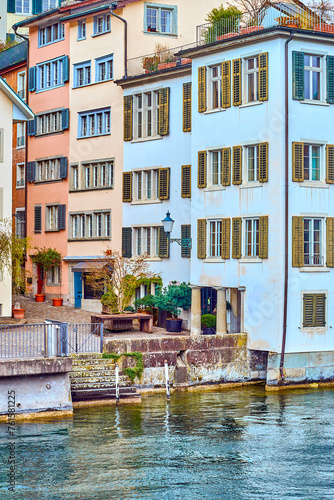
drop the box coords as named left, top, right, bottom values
left=91, top=313, right=153, bottom=333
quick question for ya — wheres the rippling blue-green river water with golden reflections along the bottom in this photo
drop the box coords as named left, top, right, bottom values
left=0, top=386, right=334, bottom=500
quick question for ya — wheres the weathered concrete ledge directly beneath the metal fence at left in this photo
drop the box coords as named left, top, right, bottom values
left=0, top=357, right=72, bottom=378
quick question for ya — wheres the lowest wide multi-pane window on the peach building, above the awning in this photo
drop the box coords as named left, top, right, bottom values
left=70, top=210, right=111, bottom=240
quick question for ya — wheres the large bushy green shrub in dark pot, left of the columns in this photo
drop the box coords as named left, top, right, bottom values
left=154, top=282, right=191, bottom=332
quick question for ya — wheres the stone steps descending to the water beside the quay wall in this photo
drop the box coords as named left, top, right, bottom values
left=70, top=353, right=140, bottom=402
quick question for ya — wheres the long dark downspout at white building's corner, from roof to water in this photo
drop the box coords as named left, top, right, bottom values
left=279, top=35, right=293, bottom=383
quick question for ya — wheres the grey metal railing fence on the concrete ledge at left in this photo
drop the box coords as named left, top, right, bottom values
left=0, top=320, right=103, bottom=359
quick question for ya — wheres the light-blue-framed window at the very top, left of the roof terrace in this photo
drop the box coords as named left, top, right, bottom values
left=145, top=4, right=177, bottom=35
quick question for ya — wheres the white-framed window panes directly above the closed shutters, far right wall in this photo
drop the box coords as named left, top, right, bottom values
left=304, top=218, right=324, bottom=266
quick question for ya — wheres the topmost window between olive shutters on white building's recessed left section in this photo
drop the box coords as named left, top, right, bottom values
left=134, top=91, right=159, bottom=139
